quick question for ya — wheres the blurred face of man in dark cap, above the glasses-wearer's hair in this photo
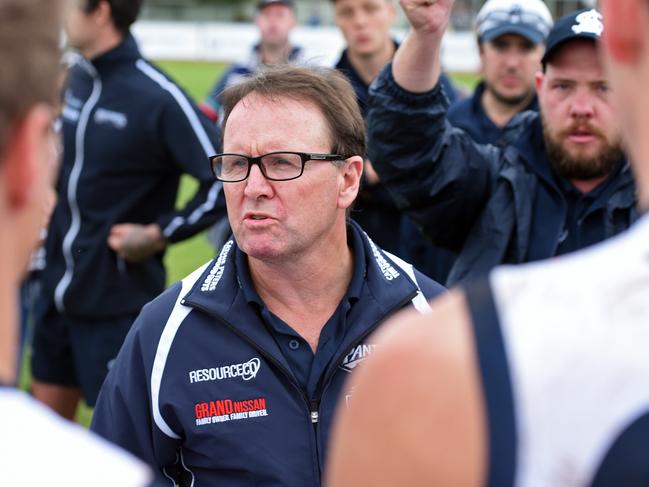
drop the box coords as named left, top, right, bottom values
left=256, top=0, right=297, bottom=49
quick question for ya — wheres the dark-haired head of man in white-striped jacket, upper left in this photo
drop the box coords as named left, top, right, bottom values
left=65, top=0, right=143, bottom=58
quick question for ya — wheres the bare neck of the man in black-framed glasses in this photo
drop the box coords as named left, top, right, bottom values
left=248, top=229, right=354, bottom=351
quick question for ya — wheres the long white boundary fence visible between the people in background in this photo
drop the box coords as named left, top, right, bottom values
left=133, top=21, right=479, bottom=72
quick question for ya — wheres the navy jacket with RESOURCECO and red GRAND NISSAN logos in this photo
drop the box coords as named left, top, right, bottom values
left=92, top=222, right=443, bottom=487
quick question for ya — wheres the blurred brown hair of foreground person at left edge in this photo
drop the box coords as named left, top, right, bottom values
left=0, top=0, right=61, bottom=154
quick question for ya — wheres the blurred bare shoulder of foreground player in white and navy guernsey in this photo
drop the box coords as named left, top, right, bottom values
left=326, top=291, right=485, bottom=487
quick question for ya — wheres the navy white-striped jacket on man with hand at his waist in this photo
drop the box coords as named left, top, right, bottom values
left=43, top=36, right=225, bottom=319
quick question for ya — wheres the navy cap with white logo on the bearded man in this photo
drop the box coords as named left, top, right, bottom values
left=541, top=9, right=604, bottom=66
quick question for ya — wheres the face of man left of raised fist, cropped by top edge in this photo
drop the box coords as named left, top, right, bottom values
left=331, top=0, right=396, bottom=57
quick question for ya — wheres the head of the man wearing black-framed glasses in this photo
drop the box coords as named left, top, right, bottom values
left=214, top=66, right=365, bottom=262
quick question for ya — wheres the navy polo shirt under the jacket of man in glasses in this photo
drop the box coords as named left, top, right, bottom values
left=235, top=227, right=366, bottom=398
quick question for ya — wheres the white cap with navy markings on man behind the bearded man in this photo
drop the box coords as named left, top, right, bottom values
left=476, top=0, right=552, bottom=44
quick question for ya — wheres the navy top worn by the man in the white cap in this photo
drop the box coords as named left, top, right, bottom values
left=447, top=81, right=539, bottom=145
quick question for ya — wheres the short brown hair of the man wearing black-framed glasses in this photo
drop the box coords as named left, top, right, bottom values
left=221, top=65, right=365, bottom=158
